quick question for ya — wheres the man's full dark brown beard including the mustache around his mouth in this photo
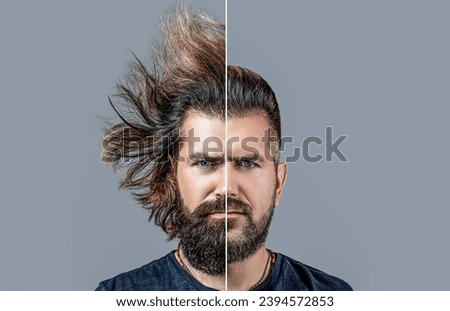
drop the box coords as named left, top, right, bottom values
left=177, top=196, right=275, bottom=275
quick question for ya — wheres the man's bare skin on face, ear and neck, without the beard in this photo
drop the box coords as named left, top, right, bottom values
left=176, top=112, right=287, bottom=290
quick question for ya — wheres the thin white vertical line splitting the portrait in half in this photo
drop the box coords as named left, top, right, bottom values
left=224, top=0, right=228, bottom=291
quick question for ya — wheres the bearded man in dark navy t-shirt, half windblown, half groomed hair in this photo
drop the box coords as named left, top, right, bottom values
left=97, top=8, right=351, bottom=290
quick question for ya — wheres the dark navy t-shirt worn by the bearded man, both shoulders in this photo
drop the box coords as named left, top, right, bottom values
left=96, top=251, right=352, bottom=291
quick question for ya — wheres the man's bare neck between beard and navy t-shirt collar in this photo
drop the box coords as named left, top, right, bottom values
left=177, top=246, right=271, bottom=290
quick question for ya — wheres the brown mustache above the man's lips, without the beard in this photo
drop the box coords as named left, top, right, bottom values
left=191, top=197, right=252, bottom=218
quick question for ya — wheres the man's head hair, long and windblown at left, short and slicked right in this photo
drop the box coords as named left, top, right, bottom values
left=102, top=6, right=281, bottom=240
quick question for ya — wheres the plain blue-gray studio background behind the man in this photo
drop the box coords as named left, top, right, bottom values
left=0, top=0, right=450, bottom=290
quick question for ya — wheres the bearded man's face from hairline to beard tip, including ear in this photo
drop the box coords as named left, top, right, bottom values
left=176, top=113, right=286, bottom=274
